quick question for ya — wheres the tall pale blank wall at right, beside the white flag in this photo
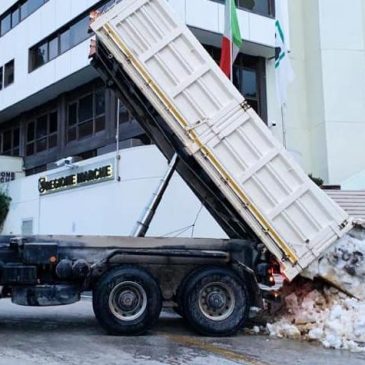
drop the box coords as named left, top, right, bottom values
left=282, top=0, right=365, bottom=189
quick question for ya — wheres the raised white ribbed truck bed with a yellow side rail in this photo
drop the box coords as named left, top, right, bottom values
left=92, top=0, right=352, bottom=279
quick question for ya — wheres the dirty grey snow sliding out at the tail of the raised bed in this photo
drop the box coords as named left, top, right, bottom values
left=302, top=227, right=365, bottom=300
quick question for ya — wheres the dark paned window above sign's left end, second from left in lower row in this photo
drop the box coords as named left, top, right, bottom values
left=26, top=111, right=58, bottom=156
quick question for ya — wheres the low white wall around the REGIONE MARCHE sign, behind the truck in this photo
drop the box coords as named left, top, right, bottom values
left=2, top=146, right=226, bottom=238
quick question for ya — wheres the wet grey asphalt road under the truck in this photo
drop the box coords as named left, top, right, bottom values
left=0, top=300, right=365, bottom=365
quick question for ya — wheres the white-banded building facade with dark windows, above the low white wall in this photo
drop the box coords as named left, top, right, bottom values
left=0, top=0, right=275, bottom=175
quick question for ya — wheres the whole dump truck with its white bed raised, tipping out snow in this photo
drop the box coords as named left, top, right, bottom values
left=0, top=0, right=362, bottom=336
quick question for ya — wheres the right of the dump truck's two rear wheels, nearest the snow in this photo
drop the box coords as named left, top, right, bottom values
left=183, top=267, right=249, bottom=336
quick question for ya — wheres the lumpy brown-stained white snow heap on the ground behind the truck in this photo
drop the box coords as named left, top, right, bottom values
left=267, top=283, right=365, bottom=352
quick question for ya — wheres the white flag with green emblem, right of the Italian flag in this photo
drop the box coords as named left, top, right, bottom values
left=275, top=0, right=294, bottom=106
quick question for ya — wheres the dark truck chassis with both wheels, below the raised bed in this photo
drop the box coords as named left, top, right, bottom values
left=0, top=236, right=266, bottom=336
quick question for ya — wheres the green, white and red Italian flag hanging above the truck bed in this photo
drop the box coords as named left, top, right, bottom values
left=220, top=0, right=242, bottom=78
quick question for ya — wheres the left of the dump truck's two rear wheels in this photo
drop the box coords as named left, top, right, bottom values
left=93, top=267, right=162, bottom=335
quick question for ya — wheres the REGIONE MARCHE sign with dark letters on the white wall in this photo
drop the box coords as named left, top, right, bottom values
left=38, top=159, right=114, bottom=195
